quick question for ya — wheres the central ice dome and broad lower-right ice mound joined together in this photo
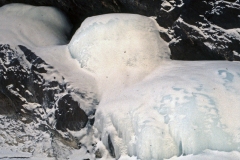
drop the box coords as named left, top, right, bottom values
left=69, top=14, right=240, bottom=160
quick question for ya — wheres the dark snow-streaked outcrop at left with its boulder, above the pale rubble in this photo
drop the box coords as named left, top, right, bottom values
left=0, top=45, right=88, bottom=131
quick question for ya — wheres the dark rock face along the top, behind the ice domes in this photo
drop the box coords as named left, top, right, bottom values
left=0, top=0, right=240, bottom=60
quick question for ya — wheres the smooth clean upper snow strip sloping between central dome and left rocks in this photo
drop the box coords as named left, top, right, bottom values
left=35, top=45, right=96, bottom=97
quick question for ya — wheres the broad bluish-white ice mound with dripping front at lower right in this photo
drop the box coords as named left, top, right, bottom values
left=95, top=61, right=240, bottom=160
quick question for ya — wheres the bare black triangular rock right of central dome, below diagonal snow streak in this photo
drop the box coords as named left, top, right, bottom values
left=169, top=22, right=225, bottom=60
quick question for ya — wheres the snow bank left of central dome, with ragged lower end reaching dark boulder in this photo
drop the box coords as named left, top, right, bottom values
left=34, top=45, right=98, bottom=114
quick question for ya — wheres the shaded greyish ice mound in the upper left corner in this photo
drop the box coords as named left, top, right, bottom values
left=0, top=4, right=71, bottom=47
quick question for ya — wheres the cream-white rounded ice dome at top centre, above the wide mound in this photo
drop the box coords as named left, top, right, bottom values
left=69, top=14, right=170, bottom=76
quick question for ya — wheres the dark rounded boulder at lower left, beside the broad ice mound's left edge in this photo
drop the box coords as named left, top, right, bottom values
left=55, top=94, right=88, bottom=131
